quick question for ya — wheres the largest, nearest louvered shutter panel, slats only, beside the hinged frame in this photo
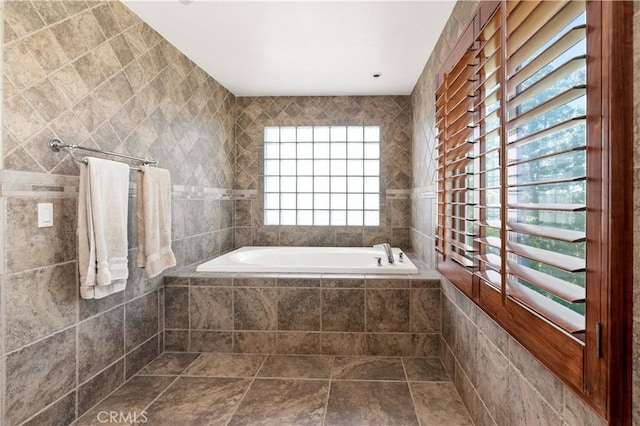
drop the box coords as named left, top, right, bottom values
left=503, top=1, right=587, bottom=338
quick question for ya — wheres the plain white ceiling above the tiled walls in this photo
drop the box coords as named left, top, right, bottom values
left=123, top=0, right=455, bottom=96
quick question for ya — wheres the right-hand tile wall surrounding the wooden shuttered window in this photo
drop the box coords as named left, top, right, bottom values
left=411, top=0, right=640, bottom=425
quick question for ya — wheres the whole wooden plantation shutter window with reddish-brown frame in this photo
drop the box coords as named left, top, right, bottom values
left=435, top=0, right=632, bottom=420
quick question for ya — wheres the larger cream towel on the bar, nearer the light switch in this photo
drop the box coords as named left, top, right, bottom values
left=78, top=157, right=129, bottom=299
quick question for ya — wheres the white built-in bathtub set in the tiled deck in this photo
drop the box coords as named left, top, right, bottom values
left=196, top=246, right=418, bottom=274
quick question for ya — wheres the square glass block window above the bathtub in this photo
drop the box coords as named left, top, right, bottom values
left=264, top=126, right=380, bottom=226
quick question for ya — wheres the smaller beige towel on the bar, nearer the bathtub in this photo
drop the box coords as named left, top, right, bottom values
left=136, top=166, right=176, bottom=278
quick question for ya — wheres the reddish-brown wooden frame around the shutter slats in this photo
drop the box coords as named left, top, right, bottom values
left=436, top=0, right=633, bottom=425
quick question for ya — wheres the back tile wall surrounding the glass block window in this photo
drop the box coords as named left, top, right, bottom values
left=235, top=96, right=411, bottom=248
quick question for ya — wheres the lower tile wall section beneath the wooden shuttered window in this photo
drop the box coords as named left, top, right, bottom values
left=440, top=279, right=605, bottom=426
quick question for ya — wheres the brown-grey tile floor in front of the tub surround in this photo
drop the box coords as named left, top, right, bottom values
left=75, top=353, right=472, bottom=426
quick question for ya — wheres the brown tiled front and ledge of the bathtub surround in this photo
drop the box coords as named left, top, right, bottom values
left=164, top=255, right=440, bottom=356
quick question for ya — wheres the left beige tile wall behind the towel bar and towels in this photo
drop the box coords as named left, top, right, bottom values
left=0, top=1, right=235, bottom=425
